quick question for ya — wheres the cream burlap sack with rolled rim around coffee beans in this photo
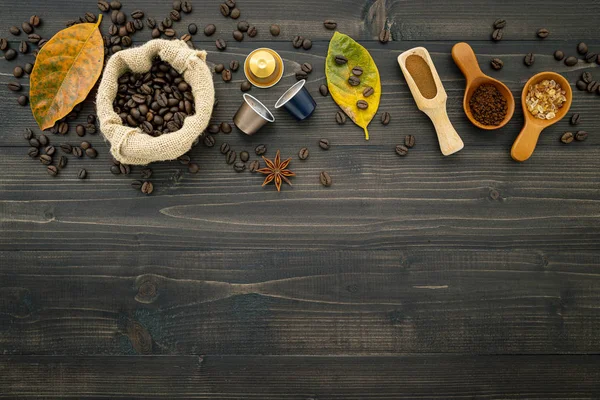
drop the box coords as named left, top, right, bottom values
left=96, top=39, right=215, bottom=165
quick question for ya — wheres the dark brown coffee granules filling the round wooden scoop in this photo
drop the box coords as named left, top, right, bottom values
left=469, top=83, right=508, bottom=126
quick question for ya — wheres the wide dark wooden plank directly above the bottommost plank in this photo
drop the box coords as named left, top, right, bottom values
left=0, top=247, right=600, bottom=355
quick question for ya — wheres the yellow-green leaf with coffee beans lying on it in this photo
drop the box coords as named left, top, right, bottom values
left=325, top=32, right=381, bottom=140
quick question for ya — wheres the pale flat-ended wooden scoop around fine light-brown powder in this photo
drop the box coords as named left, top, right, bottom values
left=398, top=47, right=464, bottom=156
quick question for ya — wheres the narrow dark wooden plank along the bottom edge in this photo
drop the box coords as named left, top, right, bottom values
left=0, top=355, right=600, bottom=400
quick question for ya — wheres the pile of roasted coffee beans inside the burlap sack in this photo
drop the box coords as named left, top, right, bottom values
left=113, top=58, right=195, bottom=136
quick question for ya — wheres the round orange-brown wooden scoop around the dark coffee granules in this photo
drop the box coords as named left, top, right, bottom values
left=452, top=42, right=515, bottom=131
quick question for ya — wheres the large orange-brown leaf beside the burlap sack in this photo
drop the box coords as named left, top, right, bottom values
left=29, top=15, right=104, bottom=130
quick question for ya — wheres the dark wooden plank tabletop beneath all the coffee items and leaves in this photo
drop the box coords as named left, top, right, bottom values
left=0, top=0, right=600, bottom=400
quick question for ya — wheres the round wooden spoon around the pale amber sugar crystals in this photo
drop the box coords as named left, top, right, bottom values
left=510, top=72, right=573, bottom=162
